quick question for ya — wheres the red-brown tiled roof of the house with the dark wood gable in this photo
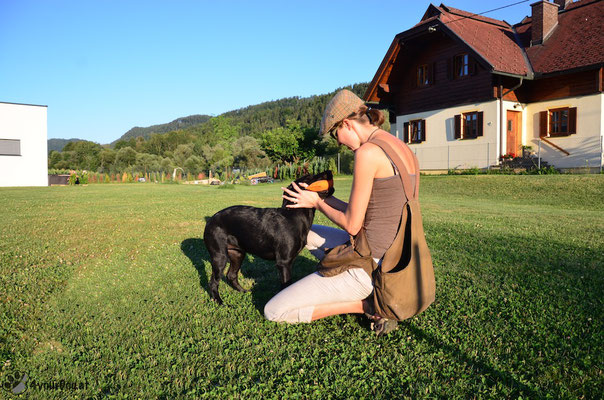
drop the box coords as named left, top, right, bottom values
left=365, top=0, right=604, bottom=101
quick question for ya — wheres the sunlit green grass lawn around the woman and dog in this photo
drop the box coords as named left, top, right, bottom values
left=0, top=175, right=604, bottom=399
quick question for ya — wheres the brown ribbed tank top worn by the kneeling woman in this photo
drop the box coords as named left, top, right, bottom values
left=363, top=156, right=415, bottom=258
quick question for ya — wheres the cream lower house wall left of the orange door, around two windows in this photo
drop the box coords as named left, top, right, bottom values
left=391, top=99, right=522, bottom=170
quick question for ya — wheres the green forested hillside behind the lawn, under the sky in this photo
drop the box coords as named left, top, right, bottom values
left=48, top=83, right=389, bottom=175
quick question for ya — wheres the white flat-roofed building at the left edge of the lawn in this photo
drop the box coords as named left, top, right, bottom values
left=0, top=102, right=48, bottom=187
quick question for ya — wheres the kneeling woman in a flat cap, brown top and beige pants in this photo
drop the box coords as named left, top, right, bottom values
left=264, top=90, right=419, bottom=329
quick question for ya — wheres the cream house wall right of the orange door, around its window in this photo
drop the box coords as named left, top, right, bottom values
left=525, top=93, right=604, bottom=168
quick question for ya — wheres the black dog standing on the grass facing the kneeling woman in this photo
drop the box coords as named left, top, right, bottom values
left=203, top=170, right=334, bottom=304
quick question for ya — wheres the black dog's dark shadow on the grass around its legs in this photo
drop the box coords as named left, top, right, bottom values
left=180, top=238, right=317, bottom=314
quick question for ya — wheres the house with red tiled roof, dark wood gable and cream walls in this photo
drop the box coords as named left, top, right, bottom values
left=364, top=0, right=604, bottom=170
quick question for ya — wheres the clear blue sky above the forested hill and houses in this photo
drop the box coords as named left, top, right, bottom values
left=0, top=0, right=531, bottom=144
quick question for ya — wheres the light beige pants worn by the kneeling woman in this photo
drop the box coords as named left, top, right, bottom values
left=264, top=225, right=373, bottom=323
